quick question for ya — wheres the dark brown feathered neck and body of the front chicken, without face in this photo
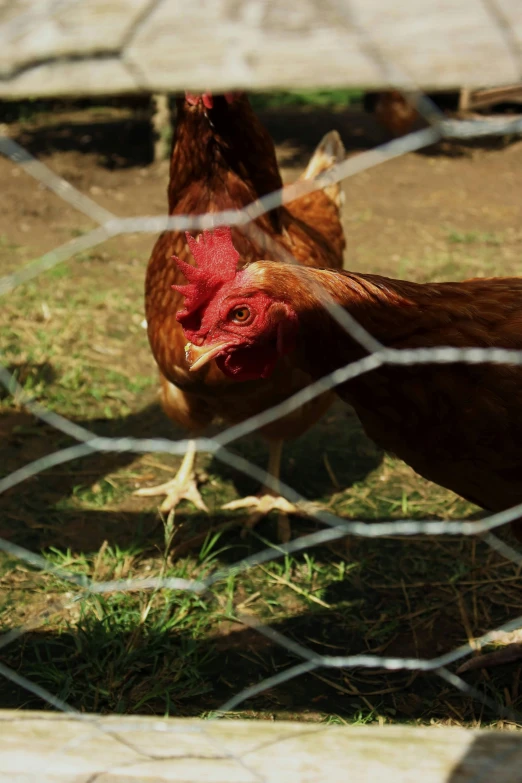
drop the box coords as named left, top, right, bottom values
left=235, top=264, right=522, bottom=511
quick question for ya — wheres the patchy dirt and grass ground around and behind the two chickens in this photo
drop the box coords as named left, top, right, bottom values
left=0, top=102, right=522, bottom=725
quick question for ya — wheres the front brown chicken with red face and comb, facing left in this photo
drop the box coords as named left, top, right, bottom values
left=178, top=238, right=522, bottom=671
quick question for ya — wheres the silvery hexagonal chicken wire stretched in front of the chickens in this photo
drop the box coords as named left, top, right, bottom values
left=0, top=75, right=522, bottom=741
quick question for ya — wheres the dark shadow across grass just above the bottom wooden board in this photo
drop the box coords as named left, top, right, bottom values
left=0, top=542, right=520, bottom=723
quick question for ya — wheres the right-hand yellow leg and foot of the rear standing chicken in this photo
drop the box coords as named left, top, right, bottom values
left=221, top=440, right=304, bottom=543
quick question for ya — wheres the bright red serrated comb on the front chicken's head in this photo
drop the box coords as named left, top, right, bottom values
left=172, top=226, right=239, bottom=320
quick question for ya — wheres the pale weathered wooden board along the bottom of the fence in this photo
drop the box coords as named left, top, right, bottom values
left=0, top=711, right=522, bottom=783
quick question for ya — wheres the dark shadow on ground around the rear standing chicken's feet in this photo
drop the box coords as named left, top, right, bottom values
left=0, top=390, right=383, bottom=552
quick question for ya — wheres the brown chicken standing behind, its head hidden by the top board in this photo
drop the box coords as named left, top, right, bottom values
left=138, top=93, right=345, bottom=538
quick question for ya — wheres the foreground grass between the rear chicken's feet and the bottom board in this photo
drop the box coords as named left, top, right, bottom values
left=0, top=480, right=518, bottom=725
